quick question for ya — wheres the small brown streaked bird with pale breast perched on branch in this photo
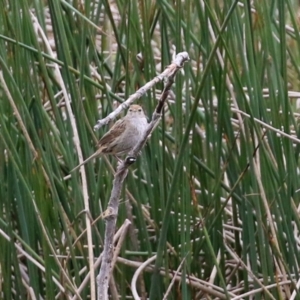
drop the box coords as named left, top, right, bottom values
left=71, top=104, right=148, bottom=172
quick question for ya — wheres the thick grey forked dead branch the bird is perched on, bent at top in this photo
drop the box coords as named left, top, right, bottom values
left=94, top=52, right=189, bottom=300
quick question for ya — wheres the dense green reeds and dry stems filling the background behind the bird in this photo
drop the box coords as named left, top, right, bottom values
left=0, top=0, right=300, bottom=299
